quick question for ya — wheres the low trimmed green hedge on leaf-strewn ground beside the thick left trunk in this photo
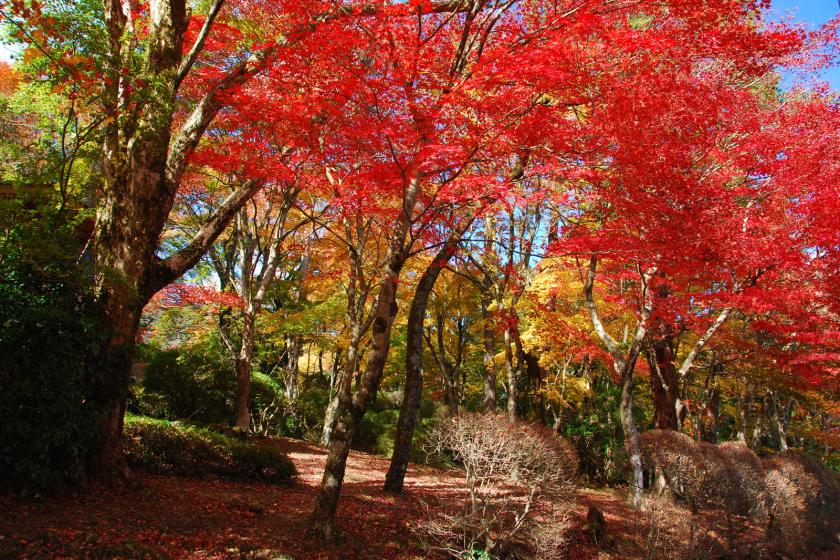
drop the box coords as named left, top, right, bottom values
left=124, top=416, right=296, bottom=482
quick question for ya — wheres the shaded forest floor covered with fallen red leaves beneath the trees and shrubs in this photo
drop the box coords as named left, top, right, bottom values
left=0, top=439, right=840, bottom=560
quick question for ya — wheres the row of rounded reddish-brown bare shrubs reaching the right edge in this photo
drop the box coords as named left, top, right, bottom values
left=640, top=430, right=840, bottom=557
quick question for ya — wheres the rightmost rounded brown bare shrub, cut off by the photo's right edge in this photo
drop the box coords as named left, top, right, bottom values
left=764, top=451, right=840, bottom=557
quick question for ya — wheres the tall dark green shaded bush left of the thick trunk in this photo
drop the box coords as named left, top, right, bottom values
left=0, top=199, right=108, bottom=487
